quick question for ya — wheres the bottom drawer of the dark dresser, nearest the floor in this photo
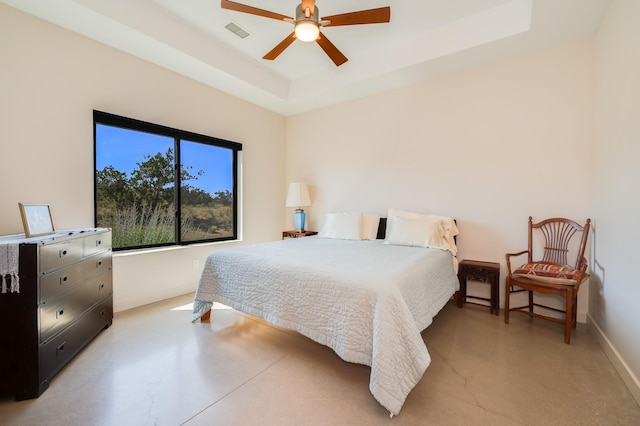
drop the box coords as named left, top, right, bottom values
left=40, top=299, right=113, bottom=382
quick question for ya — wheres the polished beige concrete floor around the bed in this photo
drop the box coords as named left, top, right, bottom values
left=0, top=295, right=640, bottom=426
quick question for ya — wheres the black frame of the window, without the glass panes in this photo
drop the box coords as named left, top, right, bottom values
left=93, top=110, right=242, bottom=251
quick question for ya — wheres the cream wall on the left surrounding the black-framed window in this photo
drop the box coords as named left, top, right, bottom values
left=0, top=5, right=286, bottom=311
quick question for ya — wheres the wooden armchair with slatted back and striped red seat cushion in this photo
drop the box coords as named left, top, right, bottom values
left=504, top=217, right=591, bottom=344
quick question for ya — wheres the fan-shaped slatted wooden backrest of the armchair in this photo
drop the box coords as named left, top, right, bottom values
left=529, top=216, right=591, bottom=271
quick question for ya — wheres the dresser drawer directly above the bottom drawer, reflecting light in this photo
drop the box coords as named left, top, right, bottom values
left=40, top=273, right=113, bottom=342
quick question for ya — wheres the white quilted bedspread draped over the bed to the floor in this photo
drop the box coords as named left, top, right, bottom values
left=193, top=237, right=458, bottom=415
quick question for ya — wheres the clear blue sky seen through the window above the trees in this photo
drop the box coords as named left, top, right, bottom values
left=96, top=124, right=233, bottom=195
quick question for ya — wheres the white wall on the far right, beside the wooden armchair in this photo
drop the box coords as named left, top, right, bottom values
left=589, top=0, right=640, bottom=403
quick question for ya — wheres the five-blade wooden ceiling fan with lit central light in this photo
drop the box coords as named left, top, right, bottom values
left=221, top=0, right=391, bottom=66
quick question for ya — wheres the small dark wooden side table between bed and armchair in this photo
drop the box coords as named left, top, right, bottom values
left=458, top=259, right=500, bottom=315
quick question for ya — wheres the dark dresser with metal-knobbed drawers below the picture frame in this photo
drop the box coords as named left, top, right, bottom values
left=0, top=228, right=113, bottom=400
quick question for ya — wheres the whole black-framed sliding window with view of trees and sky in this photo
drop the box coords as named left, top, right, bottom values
left=93, top=111, right=242, bottom=250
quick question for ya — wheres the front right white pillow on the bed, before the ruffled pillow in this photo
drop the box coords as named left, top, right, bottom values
left=384, top=216, right=448, bottom=250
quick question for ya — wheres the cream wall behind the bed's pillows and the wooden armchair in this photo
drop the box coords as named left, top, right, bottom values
left=286, top=42, right=594, bottom=322
